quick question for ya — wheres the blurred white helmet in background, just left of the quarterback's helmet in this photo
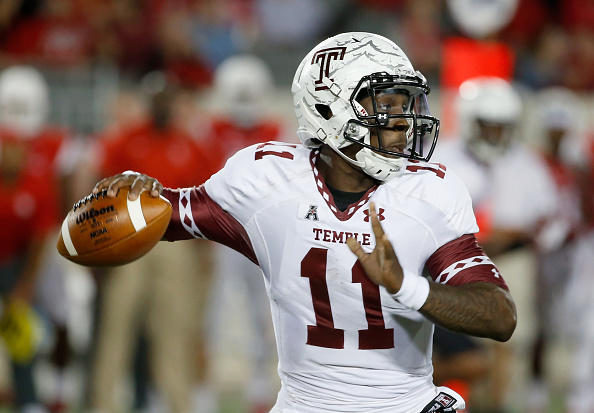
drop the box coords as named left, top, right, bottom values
left=214, top=55, right=273, bottom=127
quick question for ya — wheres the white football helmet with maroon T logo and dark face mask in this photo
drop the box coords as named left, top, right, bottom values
left=291, top=32, right=439, bottom=181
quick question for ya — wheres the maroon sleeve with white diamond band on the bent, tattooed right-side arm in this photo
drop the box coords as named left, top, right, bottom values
left=426, top=234, right=509, bottom=290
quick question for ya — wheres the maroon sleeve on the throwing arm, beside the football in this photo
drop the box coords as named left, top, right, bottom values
left=163, top=186, right=258, bottom=264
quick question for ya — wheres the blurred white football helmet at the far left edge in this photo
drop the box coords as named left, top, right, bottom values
left=0, top=66, right=49, bottom=139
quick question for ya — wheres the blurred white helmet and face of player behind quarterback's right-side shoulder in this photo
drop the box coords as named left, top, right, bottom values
left=457, top=76, right=523, bottom=163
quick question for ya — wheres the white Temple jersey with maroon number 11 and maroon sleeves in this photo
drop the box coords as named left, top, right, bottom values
left=164, top=142, right=504, bottom=413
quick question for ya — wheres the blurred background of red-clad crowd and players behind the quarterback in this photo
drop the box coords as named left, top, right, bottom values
left=0, top=0, right=594, bottom=413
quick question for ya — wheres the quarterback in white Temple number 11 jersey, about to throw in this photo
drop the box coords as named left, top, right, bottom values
left=94, top=32, right=516, bottom=413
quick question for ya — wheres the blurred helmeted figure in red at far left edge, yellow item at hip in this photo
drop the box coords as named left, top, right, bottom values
left=0, top=68, right=53, bottom=411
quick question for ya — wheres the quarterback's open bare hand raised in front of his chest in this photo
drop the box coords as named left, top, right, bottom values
left=346, top=202, right=404, bottom=294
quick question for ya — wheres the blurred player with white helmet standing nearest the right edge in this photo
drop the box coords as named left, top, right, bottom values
left=526, top=87, right=583, bottom=413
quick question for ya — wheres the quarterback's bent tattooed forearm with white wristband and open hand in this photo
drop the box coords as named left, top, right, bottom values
left=347, top=203, right=516, bottom=341
